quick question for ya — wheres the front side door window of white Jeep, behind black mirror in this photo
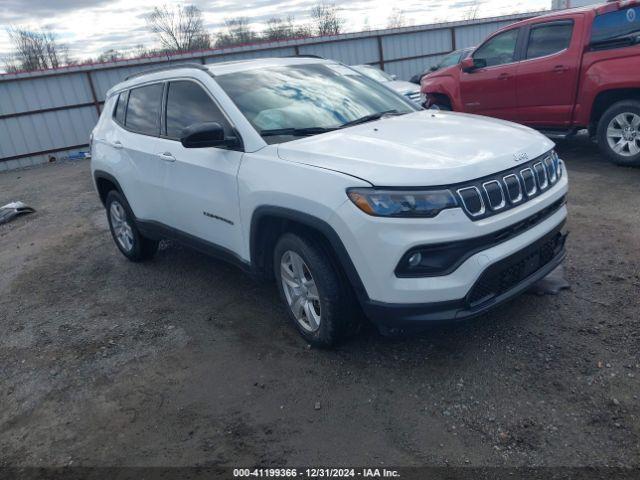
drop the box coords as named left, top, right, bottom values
left=167, top=82, right=227, bottom=139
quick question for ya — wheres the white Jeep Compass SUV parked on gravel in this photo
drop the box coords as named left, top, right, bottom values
left=92, top=57, right=567, bottom=346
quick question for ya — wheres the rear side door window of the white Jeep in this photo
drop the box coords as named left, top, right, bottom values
left=125, top=83, right=162, bottom=135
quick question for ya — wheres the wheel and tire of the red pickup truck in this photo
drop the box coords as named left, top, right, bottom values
left=597, top=100, right=640, bottom=167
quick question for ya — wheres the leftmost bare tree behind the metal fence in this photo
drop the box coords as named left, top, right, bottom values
left=7, top=27, right=71, bottom=71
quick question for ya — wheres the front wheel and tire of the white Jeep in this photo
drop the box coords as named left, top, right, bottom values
left=273, top=233, right=360, bottom=348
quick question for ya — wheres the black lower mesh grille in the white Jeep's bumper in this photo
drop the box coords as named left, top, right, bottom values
left=467, top=228, right=566, bottom=307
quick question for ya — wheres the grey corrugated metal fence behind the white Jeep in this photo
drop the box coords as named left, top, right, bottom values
left=0, top=10, right=535, bottom=171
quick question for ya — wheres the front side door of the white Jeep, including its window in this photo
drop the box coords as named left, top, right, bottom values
left=157, top=80, right=243, bottom=252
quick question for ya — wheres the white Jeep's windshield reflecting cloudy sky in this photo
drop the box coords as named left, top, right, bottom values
left=216, top=63, right=418, bottom=143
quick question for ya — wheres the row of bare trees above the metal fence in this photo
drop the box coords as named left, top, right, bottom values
left=4, top=2, right=360, bottom=72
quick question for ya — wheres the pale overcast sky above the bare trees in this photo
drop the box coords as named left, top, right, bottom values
left=0, top=0, right=551, bottom=60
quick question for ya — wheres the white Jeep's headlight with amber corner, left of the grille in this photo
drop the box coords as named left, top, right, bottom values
left=347, top=188, right=458, bottom=218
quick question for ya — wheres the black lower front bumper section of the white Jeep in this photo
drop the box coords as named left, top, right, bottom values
left=362, top=222, right=567, bottom=331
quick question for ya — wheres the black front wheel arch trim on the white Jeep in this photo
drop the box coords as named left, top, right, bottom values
left=249, top=205, right=369, bottom=302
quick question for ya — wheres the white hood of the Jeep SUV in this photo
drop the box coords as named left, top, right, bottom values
left=278, top=110, right=554, bottom=187
